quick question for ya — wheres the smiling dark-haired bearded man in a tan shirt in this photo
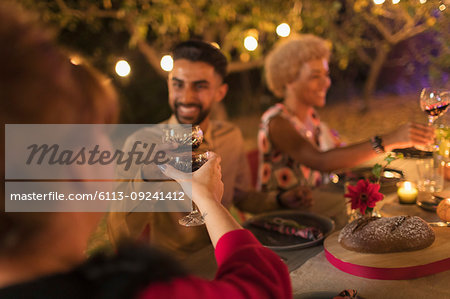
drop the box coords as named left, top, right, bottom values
left=108, top=41, right=286, bottom=258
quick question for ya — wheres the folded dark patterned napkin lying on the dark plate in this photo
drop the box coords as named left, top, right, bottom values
left=250, top=217, right=323, bottom=241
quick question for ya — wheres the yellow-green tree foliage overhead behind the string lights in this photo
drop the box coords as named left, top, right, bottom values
left=17, top=0, right=450, bottom=120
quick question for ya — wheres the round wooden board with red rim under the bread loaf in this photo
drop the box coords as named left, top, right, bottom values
left=324, top=227, right=450, bottom=280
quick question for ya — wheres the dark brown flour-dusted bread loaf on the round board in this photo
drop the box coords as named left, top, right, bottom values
left=338, top=216, right=435, bottom=253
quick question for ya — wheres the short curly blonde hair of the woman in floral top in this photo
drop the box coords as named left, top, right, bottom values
left=264, top=34, right=330, bottom=98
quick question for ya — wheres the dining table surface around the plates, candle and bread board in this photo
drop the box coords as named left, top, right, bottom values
left=183, top=157, right=450, bottom=299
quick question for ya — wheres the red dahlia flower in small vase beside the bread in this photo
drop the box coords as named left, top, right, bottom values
left=344, top=180, right=383, bottom=215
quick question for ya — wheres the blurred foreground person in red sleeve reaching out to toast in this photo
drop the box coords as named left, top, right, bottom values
left=0, top=2, right=292, bottom=299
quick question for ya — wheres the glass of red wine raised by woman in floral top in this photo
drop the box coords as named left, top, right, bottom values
left=419, top=88, right=450, bottom=151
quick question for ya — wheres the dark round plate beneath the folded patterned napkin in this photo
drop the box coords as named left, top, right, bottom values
left=243, top=211, right=334, bottom=250
